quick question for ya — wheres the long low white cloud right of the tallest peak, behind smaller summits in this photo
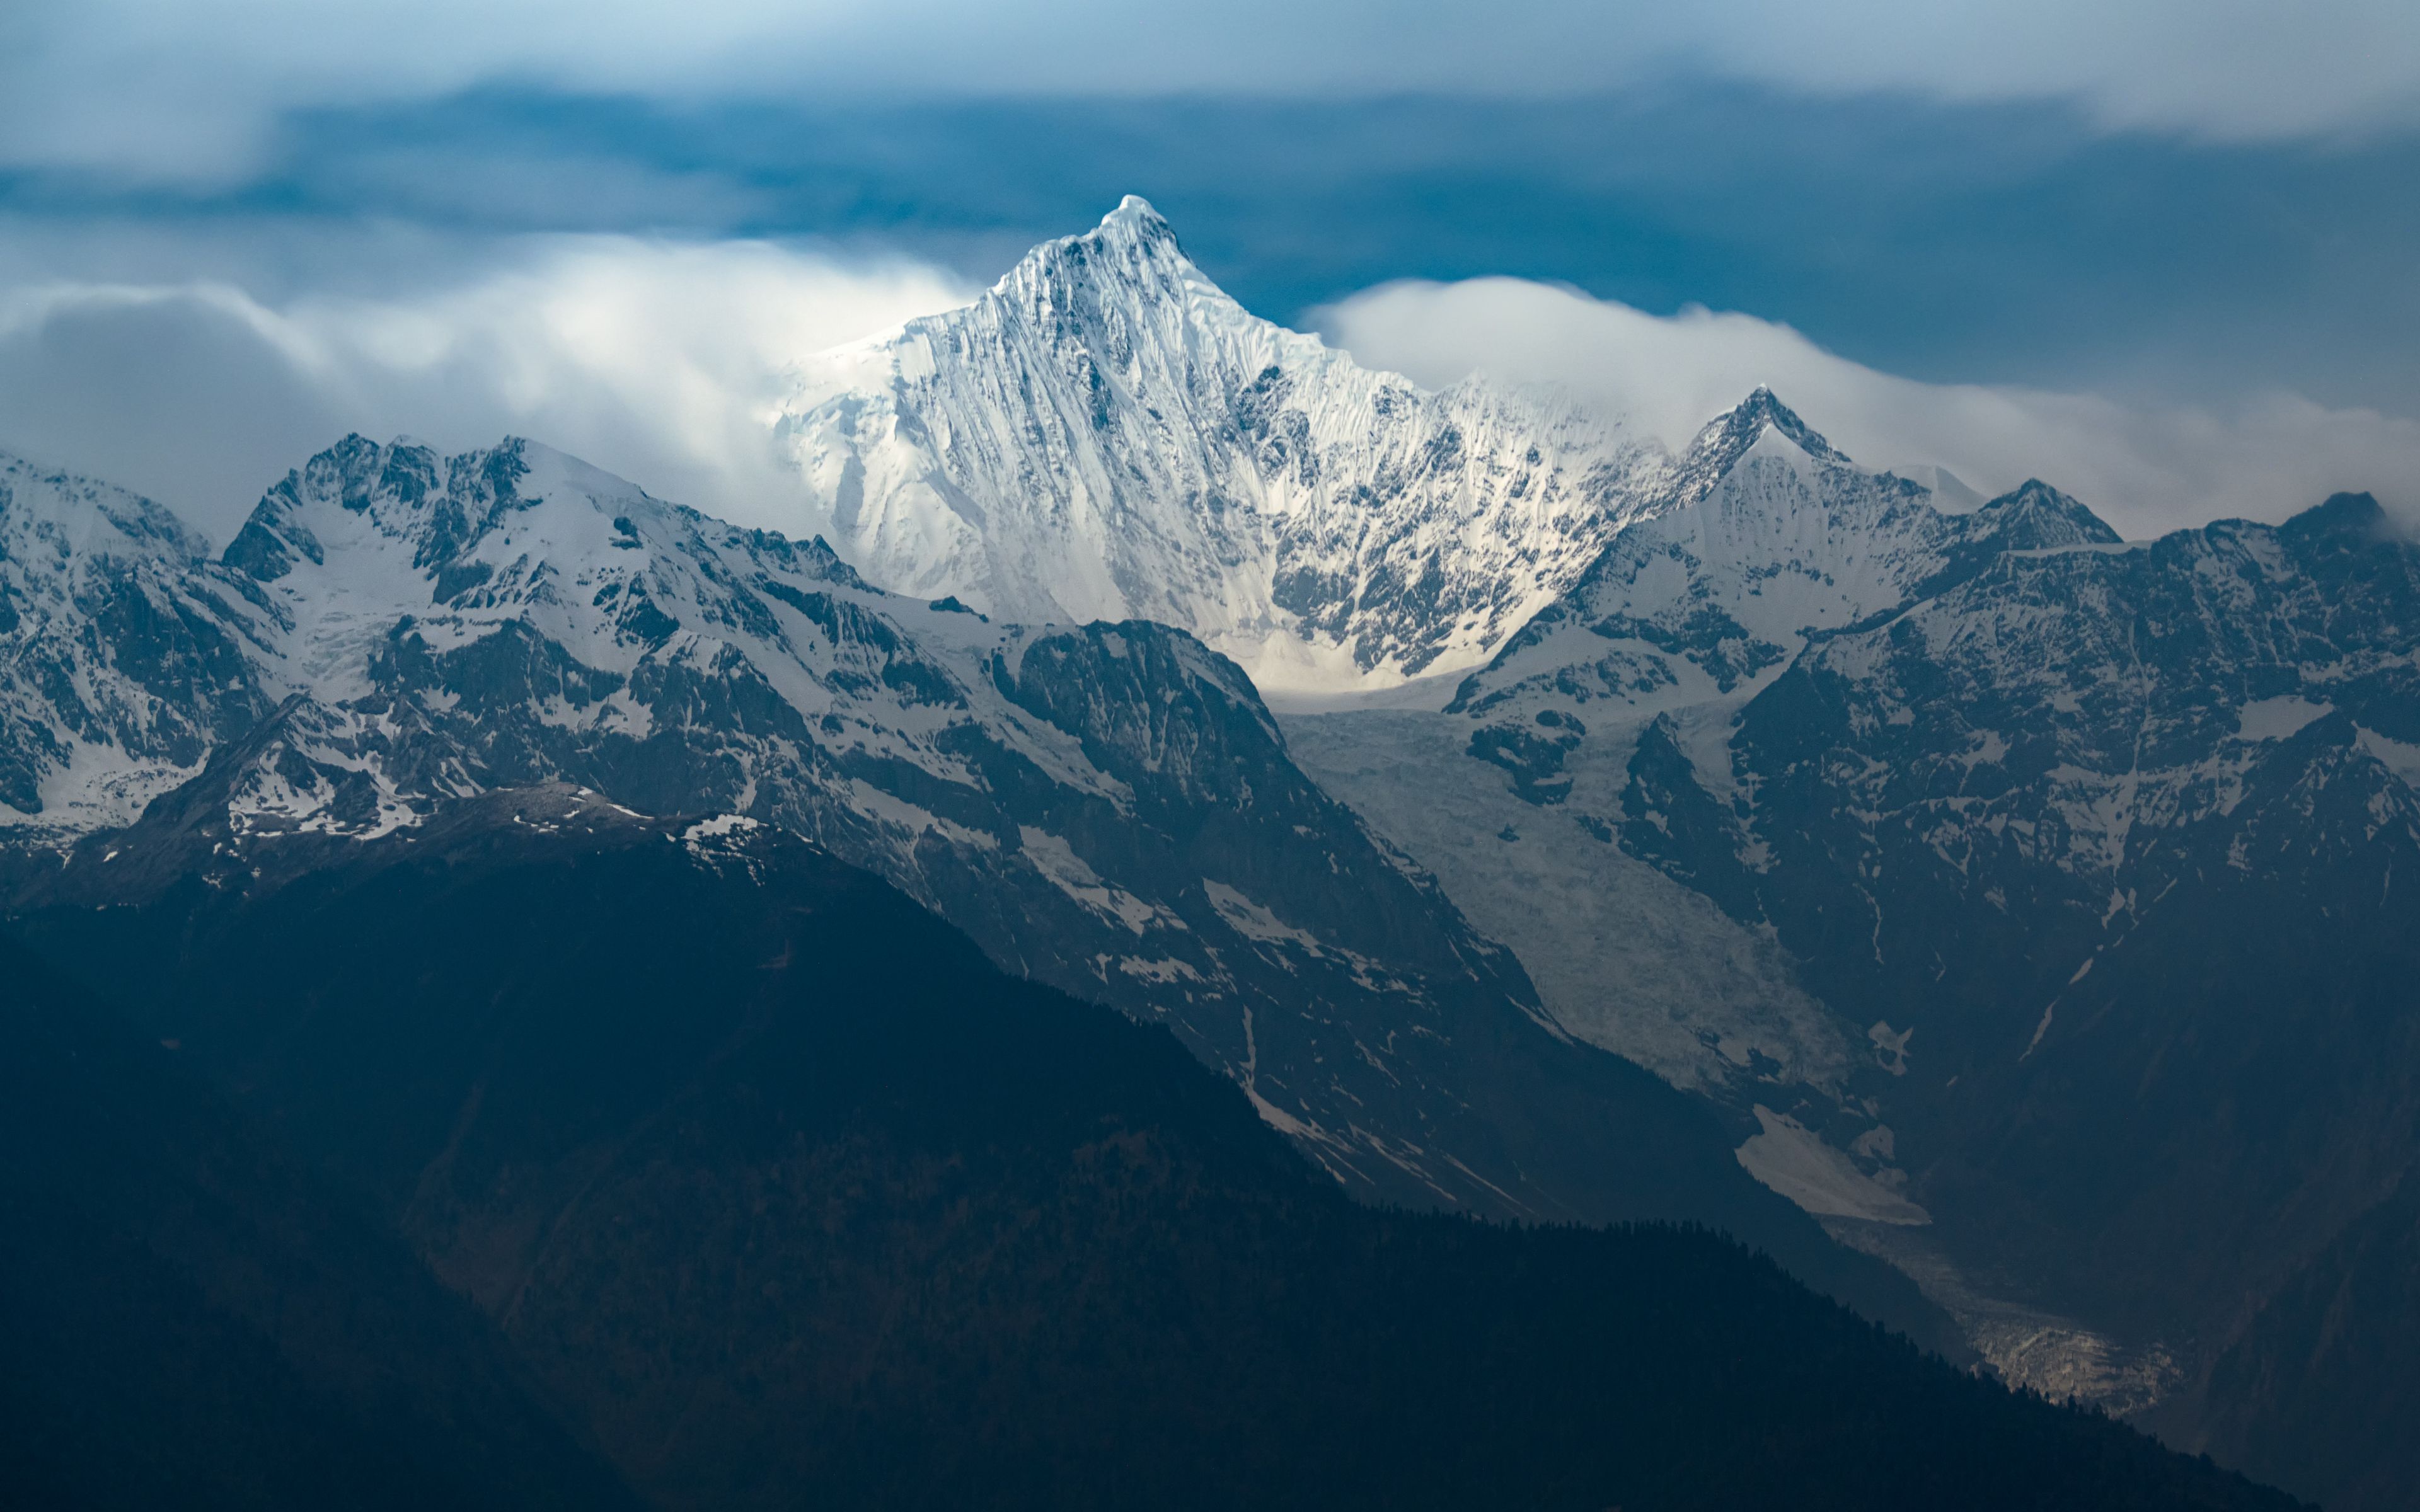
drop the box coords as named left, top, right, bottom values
left=1319, top=278, right=2420, bottom=537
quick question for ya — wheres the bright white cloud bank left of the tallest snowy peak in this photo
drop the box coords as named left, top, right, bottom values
left=0, top=237, right=973, bottom=542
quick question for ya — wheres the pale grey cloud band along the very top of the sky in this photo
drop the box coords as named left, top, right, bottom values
left=0, top=0, right=2420, bottom=179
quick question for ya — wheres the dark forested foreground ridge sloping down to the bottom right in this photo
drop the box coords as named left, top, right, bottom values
left=0, top=786, right=2290, bottom=1507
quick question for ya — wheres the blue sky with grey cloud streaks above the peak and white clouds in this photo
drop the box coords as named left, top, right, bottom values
left=0, top=0, right=2420, bottom=537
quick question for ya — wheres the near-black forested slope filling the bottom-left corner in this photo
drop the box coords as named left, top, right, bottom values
left=0, top=939, right=639, bottom=1512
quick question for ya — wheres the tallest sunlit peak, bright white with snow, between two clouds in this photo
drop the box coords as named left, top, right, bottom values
left=779, top=198, right=1674, bottom=692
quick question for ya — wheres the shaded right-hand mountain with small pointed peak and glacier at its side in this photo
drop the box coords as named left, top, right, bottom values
left=1288, top=397, right=2420, bottom=1449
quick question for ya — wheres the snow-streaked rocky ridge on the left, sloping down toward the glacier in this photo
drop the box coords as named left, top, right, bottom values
left=5, top=438, right=1922, bottom=1316
